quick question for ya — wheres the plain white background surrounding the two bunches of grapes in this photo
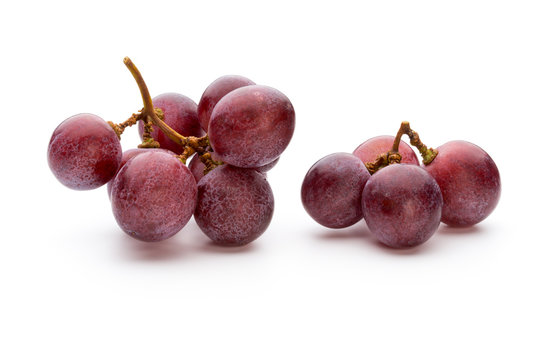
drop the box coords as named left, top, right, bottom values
left=0, top=0, right=540, bottom=359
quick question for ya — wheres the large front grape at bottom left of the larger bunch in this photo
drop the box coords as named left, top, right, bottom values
left=111, top=151, right=197, bottom=242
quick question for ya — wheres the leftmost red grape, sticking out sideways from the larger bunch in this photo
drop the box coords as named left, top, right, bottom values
left=47, top=114, right=122, bottom=190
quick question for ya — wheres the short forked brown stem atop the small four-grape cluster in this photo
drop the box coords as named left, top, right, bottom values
left=365, top=121, right=438, bottom=175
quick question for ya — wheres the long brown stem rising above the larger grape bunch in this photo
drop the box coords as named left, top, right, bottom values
left=121, top=57, right=210, bottom=164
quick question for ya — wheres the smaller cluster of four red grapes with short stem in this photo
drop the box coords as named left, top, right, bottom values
left=301, top=122, right=501, bottom=248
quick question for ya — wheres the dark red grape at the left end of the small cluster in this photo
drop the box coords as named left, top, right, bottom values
left=302, top=153, right=370, bottom=229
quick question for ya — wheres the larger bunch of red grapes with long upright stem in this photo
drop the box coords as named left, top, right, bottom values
left=47, top=58, right=295, bottom=246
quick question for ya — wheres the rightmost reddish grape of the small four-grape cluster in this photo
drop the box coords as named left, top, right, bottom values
left=425, top=141, right=501, bottom=227
